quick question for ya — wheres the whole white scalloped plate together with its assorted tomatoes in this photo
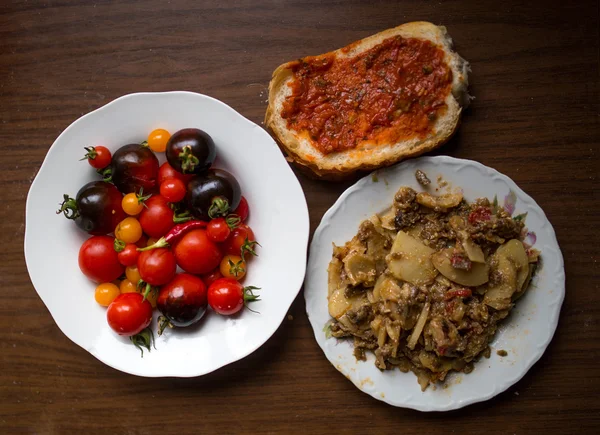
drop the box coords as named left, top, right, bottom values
left=25, top=92, right=309, bottom=377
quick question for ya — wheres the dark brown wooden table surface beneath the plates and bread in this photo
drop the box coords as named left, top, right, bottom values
left=0, top=0, right=600, bottom=434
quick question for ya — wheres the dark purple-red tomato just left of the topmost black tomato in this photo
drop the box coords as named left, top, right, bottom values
left=110, top=144, right=158, bottom=193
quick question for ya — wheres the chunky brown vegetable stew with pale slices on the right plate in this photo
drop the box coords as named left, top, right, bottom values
left=328, top=180, right=540, bottom=390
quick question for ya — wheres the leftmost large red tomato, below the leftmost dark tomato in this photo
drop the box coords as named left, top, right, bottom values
left=79, top=236, right=125, bottom=283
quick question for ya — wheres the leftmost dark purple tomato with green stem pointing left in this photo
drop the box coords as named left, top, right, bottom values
left=57, top=181, right=126, bottom=236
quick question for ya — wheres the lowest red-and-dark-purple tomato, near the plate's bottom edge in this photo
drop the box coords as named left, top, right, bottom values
left=156, top=273, right=208, bottom=327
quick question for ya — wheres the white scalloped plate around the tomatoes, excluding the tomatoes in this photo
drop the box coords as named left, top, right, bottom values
left=25, top=92, right=309, bottom=377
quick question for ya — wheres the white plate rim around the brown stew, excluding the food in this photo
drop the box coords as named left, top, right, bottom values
left=304, top=156, right=565, bottom=411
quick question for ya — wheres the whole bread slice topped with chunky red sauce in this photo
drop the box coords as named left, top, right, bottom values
left=265, top=22, right=469, bottom=179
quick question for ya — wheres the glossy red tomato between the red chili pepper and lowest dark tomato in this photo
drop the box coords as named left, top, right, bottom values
left=173, top=229, right=223, bottom=274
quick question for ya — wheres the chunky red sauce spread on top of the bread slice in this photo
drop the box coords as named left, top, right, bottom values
left=281, top=36, right=452, bottom=154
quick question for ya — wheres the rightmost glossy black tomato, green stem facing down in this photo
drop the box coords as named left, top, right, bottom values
left=186, top=169, right=242, bottom=221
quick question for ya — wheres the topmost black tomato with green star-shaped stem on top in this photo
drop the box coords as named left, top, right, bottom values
left=166, top=128, right=217, bottom=174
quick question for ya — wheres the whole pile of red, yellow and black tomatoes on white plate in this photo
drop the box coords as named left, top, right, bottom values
left=57, top=128, right=258, bottom=356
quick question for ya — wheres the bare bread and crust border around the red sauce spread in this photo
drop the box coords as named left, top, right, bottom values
left=265, top=22, right=470, bottom=179
